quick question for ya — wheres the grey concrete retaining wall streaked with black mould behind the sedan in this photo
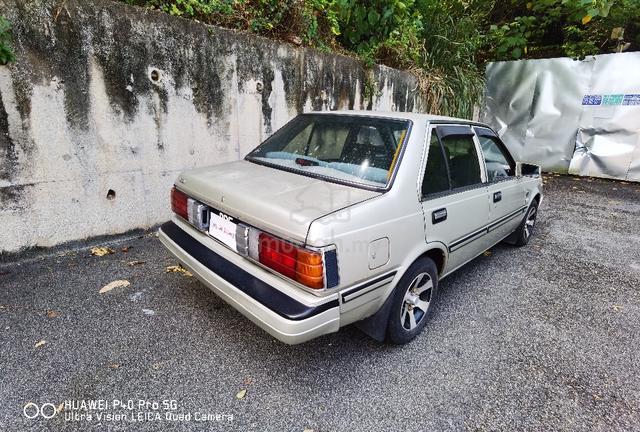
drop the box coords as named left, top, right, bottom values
left=0, top=0, right=421, bottom=253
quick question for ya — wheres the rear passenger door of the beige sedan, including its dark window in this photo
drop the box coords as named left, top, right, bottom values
left=422, top=125, right=489, bottom=272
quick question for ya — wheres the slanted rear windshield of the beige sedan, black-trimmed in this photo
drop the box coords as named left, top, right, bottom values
left=247, top=114, right=410, bottom=188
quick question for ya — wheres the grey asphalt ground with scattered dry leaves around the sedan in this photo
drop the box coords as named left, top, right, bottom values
left=0, top=175, right=640, bottom=432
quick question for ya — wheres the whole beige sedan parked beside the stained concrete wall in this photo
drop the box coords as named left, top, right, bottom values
left=160, top=111, right=542, bottom=344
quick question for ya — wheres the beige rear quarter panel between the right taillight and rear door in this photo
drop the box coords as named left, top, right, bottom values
left=307, top=122, right=444, bottom=326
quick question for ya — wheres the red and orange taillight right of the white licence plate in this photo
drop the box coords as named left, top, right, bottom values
left=258, top=233, right=324, bottom=289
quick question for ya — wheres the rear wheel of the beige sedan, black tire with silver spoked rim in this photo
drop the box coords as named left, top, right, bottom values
left=387, top=258, right=438, bottom=344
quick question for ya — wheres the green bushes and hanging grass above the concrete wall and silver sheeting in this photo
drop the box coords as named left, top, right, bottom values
left=124, top=0, right=640, bottom=117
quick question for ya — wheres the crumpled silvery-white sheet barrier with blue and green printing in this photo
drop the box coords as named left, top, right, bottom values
left=481, top=52, right=640, bottom=182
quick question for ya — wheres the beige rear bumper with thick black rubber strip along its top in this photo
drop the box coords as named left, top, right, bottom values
left=159, top=222, right=340, bottom=344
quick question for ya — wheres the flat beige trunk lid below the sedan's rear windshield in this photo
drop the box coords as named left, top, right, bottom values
left=176, top=160, right=380, bottom=242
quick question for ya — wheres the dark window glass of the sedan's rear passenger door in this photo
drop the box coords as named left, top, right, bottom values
left=422, top=130, right=482, bottom=195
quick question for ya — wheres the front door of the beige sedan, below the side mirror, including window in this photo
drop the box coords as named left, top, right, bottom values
left=474, top=127, right=525, bottom=246
